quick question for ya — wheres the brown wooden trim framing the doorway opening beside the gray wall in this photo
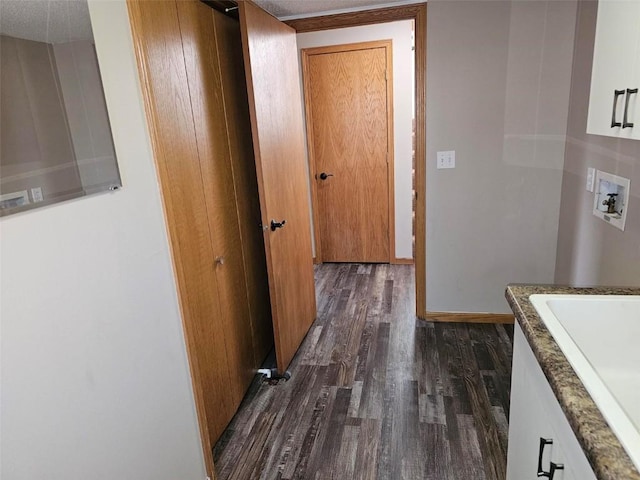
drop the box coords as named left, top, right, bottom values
left=284, top=3, right=427, bottom=319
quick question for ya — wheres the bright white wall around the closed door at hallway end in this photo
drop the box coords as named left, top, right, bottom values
left=297, top=20, right=414, bottom=258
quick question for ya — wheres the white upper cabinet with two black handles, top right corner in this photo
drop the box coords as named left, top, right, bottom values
left=587, top=0, right=640, bottom=139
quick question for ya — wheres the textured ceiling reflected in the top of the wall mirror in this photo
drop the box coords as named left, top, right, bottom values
left=0, top=0, right=93, bottom=43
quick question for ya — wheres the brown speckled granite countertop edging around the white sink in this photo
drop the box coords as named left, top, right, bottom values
left=505, top=284, right=640, bottom=480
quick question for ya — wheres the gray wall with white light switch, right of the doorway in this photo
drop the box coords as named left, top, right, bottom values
left=427, top=0, right=576, bottom=313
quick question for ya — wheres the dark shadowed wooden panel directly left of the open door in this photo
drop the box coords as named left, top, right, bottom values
left=213, top=10, right=273, bottom=366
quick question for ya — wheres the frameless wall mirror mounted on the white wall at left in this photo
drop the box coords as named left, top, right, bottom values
left=0, top=0, right=122, bottom=216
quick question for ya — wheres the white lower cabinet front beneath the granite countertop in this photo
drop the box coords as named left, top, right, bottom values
left=507, top=323, right=596, bottom=480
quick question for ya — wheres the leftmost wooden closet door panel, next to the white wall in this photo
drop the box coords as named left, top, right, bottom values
left=128, top=0, right=235, bottom=454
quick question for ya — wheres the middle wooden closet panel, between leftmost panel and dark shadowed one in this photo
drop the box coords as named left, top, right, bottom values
left=176, top=0, right=257, bottom=412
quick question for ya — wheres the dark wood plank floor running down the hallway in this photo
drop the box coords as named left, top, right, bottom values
left=214, top=264, right=513, bottom=480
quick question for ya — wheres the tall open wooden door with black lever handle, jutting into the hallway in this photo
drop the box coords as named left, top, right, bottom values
left=239, top=1, right=316, bottom=373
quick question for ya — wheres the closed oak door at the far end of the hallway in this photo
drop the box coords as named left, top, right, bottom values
left=303, top=40, right=395, bottom=262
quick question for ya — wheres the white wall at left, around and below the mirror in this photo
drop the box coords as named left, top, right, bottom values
left=0, top=1, right=205, bottom=480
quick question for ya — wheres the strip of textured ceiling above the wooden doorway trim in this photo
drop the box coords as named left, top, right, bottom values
left=254, top=0, right=425, bottom=19
